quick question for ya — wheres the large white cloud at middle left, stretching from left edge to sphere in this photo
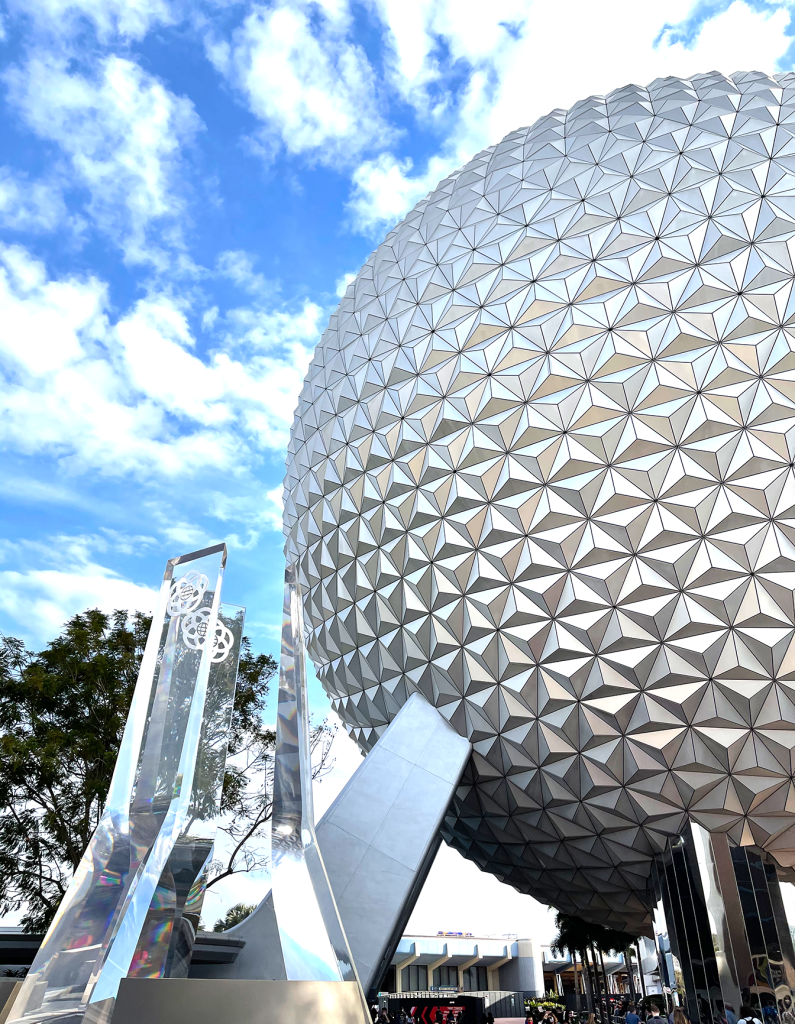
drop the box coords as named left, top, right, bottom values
left=0, top=247, right=321, bottom=479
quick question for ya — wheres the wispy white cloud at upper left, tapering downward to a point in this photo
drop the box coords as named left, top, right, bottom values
left=5, top=51, right=201, bottom=262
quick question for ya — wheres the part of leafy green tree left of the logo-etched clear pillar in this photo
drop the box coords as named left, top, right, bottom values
left=0, top=611, right=149, bottom=931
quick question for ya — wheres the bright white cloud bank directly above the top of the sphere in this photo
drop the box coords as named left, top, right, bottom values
left=348, top=0, right=792, bottom=233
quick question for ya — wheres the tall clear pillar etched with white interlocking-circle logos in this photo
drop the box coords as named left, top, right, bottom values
left=7, top=544, right=245, bottom=1024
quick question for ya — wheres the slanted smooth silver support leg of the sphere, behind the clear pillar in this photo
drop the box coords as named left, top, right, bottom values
left=204, top=694, right=471, bottom=992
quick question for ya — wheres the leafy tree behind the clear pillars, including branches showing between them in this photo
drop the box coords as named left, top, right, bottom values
left=0, top=609, right=319, bottom=932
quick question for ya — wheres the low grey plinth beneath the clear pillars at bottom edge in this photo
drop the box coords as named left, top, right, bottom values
left=112, top=978, right=371, bottom=1024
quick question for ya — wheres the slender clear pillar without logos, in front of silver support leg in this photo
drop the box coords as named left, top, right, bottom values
left=271, top=565, right=359, bottom=983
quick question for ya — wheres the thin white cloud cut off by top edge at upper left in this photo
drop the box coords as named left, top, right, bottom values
left=8, top=0, right=173, bottom=40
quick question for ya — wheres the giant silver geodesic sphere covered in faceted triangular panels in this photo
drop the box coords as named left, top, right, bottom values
left=285, top=74, right=795, bottom=926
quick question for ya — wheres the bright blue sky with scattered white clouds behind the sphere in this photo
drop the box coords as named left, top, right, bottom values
left=0, top=0, right=793, bottom=928
